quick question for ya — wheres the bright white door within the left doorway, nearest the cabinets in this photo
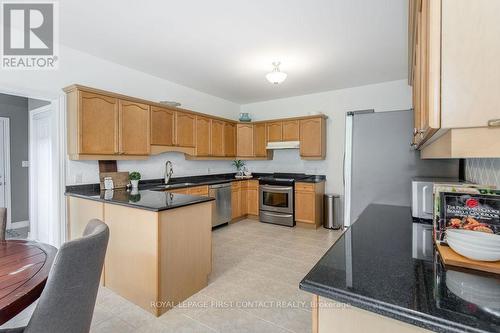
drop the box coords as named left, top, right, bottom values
left=30, top=108, right=55, bottom=244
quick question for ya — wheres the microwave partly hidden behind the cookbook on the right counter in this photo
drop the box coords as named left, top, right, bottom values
left=411, top=177, right=463, bottom=220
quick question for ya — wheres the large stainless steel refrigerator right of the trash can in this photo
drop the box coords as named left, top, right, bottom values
left=344, top=110, right=459, bottom=226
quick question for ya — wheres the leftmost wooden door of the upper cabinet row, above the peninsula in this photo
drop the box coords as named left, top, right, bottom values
left=78, top=91, right=119, bottom=155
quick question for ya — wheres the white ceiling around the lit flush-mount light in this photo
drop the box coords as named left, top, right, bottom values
left=60, top=0, right=408, bottom=104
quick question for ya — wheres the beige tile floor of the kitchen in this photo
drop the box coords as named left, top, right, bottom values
left=0, top=220, right=340, bottom=333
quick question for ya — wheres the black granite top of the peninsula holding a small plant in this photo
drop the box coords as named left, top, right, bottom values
left=65, top=188, right=215, bottom=212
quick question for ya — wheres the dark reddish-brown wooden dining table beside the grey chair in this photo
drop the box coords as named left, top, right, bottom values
left=0, top=240, right=57, bottom=325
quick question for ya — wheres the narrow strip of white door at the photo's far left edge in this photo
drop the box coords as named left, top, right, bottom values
left=0, top=117, right=11, bottom=228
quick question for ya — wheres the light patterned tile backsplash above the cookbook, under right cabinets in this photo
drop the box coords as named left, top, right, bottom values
left=465, top=158, right=500, bottom=188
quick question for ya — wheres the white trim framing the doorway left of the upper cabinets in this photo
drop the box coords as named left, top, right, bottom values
left=0, top=85, right=67, bottom=247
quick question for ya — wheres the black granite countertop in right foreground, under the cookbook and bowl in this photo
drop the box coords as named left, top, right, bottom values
left=300, top=205, right=500, bottom=332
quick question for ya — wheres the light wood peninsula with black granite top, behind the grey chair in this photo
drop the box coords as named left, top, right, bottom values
left=66, top=187, right=214, bottom=316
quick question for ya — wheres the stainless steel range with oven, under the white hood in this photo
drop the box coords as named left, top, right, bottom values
left=259, top=173, right=307, bottom=227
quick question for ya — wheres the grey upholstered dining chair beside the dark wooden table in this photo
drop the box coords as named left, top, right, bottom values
left=0, top=219, right=109, bottom=333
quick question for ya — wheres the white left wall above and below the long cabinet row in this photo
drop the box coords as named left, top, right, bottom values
left=0, top=46, right=239, bottom=185
